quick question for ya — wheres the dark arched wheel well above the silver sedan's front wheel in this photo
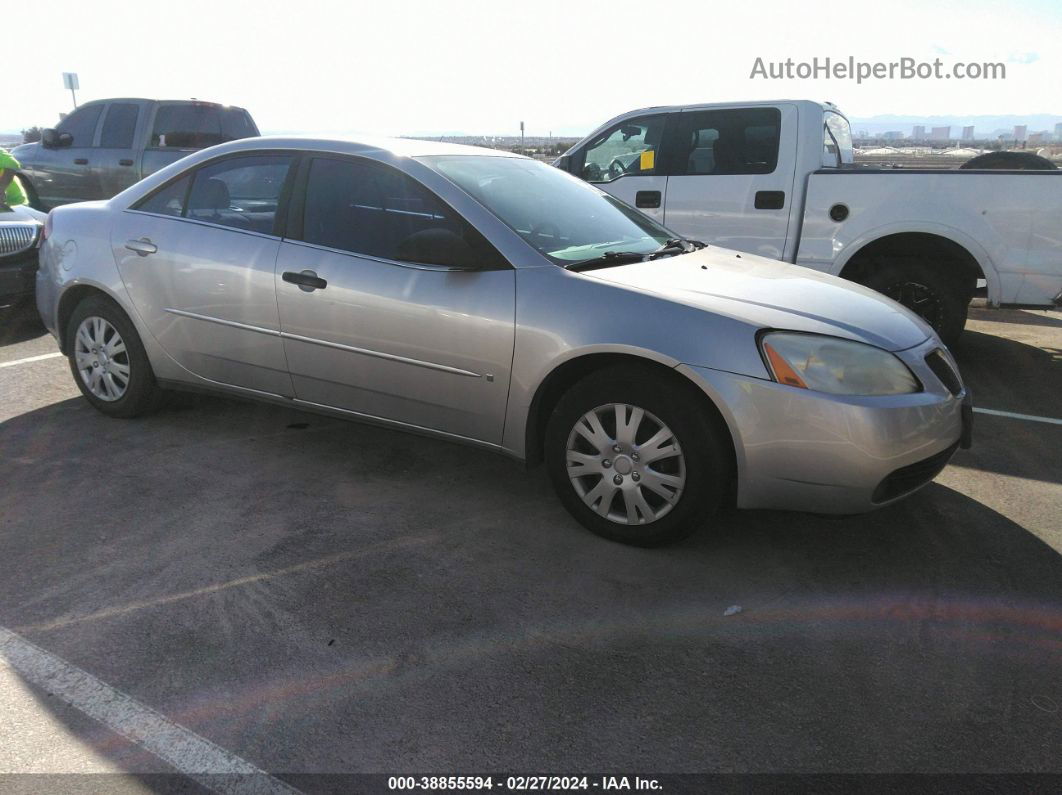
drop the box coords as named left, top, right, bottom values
left=525, top=353, right=736, bottom=472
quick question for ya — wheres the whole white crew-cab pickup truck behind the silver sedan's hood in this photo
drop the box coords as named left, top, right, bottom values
left=554, top=100, right=1062, bottom=344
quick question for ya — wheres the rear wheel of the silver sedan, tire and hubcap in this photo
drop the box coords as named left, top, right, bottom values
left=66, top=295, right=161, bottom=418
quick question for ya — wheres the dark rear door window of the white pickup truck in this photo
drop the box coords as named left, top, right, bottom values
left=674, top=107, right=782, bottom=175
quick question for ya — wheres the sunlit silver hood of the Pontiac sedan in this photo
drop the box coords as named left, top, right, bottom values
left=583, top=246, right=933, bottom=350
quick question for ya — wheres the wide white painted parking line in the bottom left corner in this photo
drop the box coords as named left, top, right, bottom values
left=0, top=626, right=298, bottom=794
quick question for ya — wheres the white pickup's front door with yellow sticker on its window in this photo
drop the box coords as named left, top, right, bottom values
left=569, top=114, right=673, bottom=222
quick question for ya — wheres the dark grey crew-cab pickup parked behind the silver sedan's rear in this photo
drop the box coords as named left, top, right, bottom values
left=12, top=99, right=258, bottom=209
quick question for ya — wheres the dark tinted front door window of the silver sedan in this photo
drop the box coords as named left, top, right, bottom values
left=302, top=157, right=500, bottom=267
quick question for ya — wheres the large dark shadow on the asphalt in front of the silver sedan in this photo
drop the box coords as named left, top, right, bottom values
left=0, top=397, right=1062, bottom=773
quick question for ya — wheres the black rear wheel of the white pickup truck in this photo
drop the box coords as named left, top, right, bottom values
left=861, top=258, right=973, bottom=347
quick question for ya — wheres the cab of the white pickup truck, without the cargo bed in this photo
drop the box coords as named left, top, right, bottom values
left=556, top=100, right=853, bottom=261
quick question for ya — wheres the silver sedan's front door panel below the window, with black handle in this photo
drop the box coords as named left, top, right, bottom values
left=276, top=241, right=515, bottom=444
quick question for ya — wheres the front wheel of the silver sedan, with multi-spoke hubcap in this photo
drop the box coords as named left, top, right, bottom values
left=545, top=366, right=733, bottom=547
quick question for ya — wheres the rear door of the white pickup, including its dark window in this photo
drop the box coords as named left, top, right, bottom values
left=663, top=105, right=797, bottom=259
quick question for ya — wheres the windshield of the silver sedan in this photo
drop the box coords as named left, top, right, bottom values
left=421, top=155, right=676, bottom=265
